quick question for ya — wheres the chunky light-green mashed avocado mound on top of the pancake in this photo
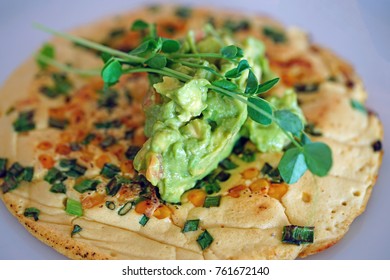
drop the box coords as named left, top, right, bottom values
left=134, top=31, right=301, bottom=203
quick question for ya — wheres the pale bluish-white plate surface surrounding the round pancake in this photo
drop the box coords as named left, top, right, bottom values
left=0, top=0, right=390, bottom=259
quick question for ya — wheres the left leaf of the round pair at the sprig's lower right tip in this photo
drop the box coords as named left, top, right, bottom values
left=278, top=148, right=307, bottom=184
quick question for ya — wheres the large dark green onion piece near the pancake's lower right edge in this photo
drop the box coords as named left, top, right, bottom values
left=282, top=225, right=314, bottom=245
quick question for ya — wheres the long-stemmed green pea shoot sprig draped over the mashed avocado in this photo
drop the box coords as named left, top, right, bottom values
left=35, top=20, right=332, bottom=184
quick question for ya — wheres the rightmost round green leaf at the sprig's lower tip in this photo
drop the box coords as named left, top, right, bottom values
left=303, top=142, right=333, bottom=177
